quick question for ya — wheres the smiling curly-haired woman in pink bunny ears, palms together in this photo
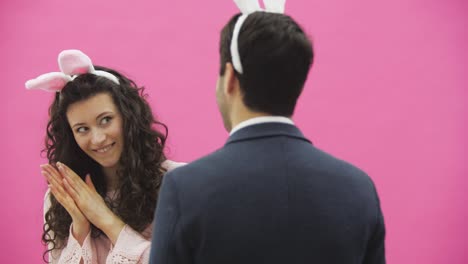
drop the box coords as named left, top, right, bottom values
left=26, top=50, right=181, bottom=263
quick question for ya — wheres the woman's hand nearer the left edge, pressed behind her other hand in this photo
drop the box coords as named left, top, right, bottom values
left=41, top=164, right=91, bottom=245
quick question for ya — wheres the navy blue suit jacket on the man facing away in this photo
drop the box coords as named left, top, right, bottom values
left=150, top=123, right=385, bottom=264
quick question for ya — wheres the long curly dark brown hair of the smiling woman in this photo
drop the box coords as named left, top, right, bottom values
left=42, top=66, right=167, bottom=257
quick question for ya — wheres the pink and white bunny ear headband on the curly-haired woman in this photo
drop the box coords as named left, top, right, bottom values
left=25, top=50, right=120, bottom=92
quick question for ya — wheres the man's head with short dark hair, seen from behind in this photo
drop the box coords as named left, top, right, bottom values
left=217, top=12, right=313, bottom=130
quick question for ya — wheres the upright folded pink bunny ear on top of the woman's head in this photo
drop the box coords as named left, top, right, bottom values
left=58, top=50, right=94, bottom=75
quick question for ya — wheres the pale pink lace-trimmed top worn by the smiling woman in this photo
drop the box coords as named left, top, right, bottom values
left=44, top=160, right=185, bottom=264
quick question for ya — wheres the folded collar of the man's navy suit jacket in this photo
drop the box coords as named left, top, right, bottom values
left=226, top=123, right=312, bottom=145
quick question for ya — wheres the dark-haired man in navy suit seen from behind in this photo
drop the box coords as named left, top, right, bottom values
left=151, top=6, right=385, bottom=264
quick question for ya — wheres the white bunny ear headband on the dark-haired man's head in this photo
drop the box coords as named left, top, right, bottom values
left=231, top=0, right=286, bottom=74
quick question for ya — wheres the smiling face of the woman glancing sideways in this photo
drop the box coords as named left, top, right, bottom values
left=67, top=93, right=124, bottom=168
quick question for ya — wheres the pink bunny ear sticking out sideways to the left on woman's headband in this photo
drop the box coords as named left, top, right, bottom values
left=25, top=72, right=72, bottom=92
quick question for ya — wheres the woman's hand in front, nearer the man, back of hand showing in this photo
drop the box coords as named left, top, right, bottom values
left=57, top=162, right=125, bottom=244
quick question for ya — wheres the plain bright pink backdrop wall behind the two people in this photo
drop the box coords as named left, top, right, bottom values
left=0, top=0, right=468, bottom=264
